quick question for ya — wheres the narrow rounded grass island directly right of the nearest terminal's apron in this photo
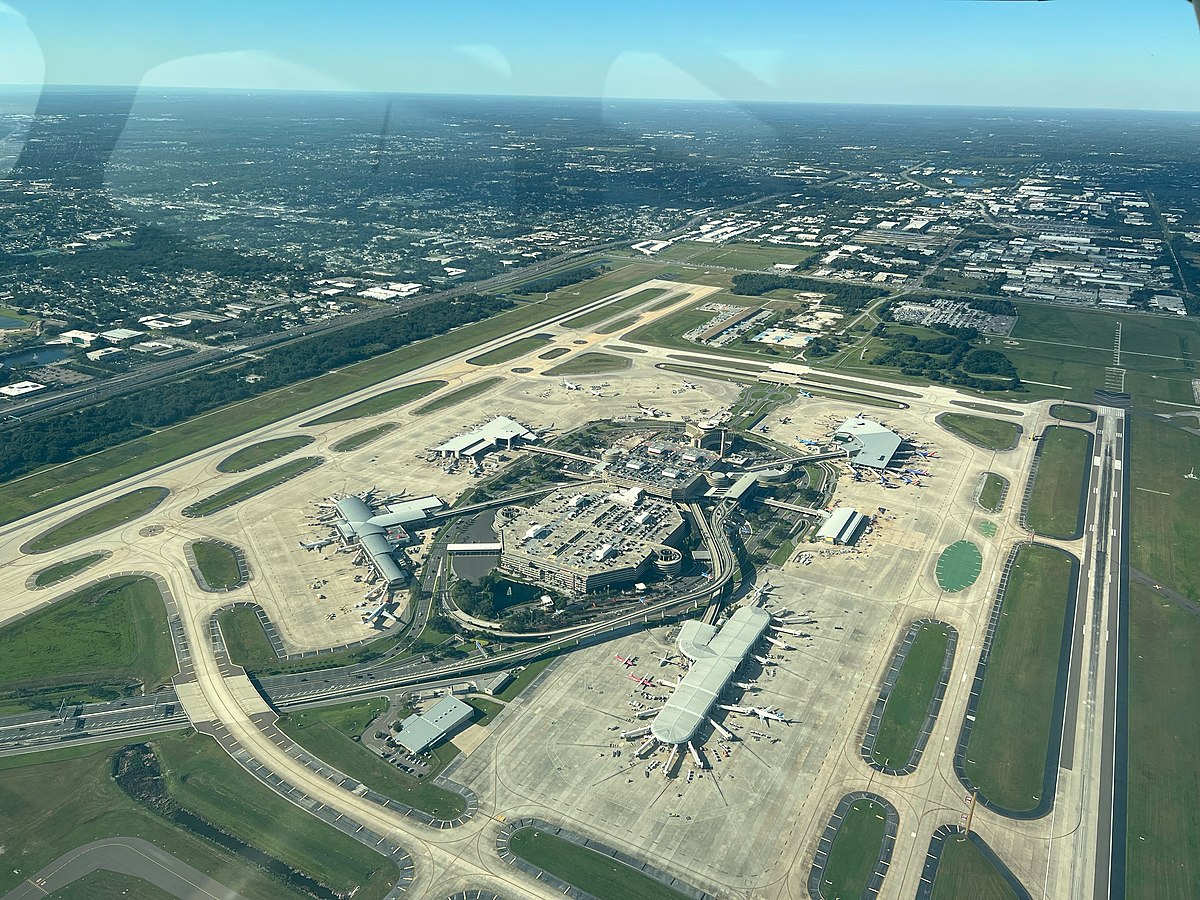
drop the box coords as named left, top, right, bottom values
left=871, top=623, right=950, bottom=769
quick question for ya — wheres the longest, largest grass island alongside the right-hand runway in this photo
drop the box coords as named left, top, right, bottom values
left=965, top=545, right=1073, bottom=811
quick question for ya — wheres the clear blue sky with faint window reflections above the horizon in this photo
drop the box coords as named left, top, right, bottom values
left=0, top=0, right=1200, bottom=112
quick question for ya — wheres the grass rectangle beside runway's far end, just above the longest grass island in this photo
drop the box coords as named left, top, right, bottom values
left=1025, top=425, right=1092, bottom=540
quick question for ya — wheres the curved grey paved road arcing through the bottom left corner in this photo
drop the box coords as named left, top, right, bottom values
left=0, top=838, right=241, bottom=900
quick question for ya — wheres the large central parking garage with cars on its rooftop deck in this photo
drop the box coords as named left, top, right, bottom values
left=496, top=487, right=684, bottom=594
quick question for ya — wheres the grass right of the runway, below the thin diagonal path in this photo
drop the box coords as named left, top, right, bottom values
left=1126, top=580, right=1200, bottom=900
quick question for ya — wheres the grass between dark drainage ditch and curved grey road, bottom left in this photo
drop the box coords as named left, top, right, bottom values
left=0, top=738, right=319, bottom=900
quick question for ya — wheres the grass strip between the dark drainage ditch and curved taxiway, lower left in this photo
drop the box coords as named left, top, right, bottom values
left=152, top=733, right=397, bottom=896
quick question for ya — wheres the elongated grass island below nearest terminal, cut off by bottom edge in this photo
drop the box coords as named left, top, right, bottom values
left=509, top=828, right=683, bottom=900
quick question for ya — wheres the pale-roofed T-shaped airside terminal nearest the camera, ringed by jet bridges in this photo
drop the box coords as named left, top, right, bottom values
left=650, top=606, right=770, bottom=744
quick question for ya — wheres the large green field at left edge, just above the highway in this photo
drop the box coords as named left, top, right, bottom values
left=0, top=576, right=178, bottom=706
